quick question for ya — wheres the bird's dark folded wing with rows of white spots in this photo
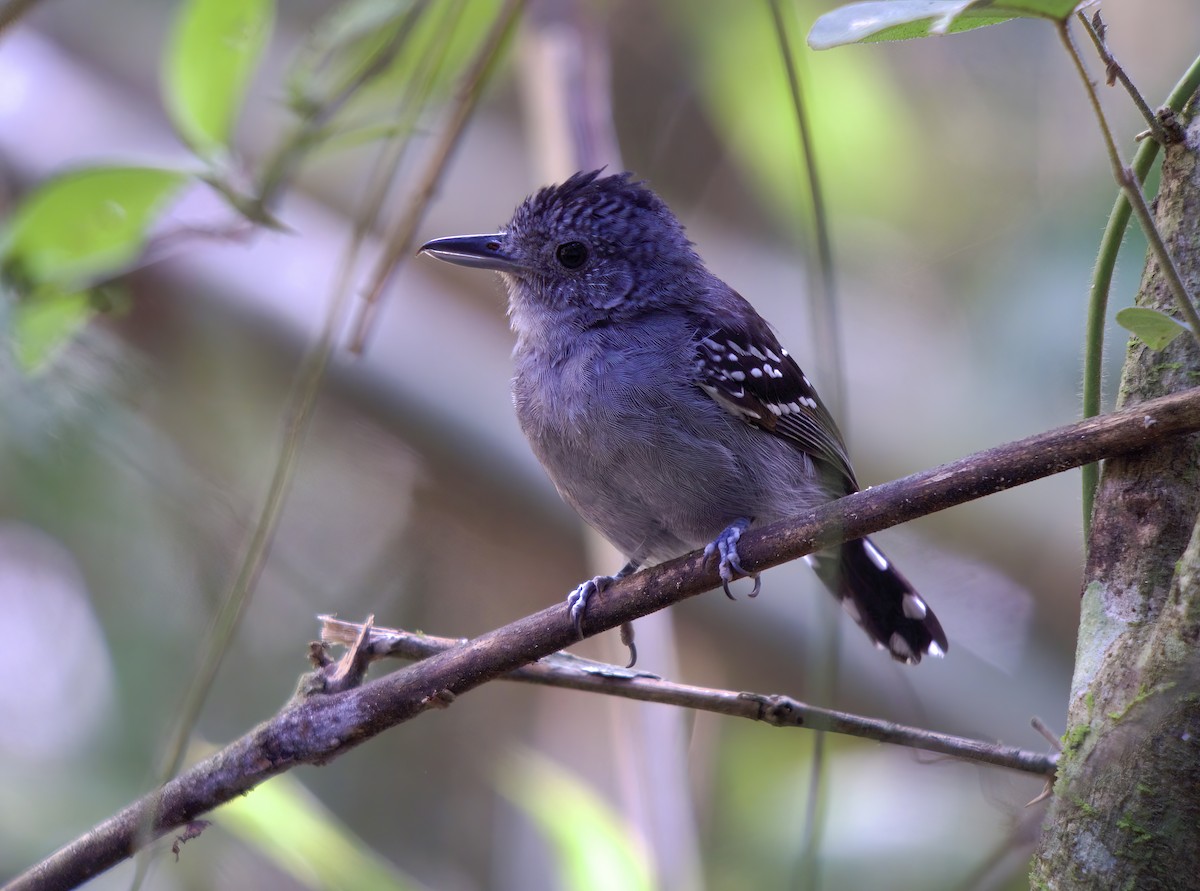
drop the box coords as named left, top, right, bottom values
left=696, top=322, right=858, bottom=491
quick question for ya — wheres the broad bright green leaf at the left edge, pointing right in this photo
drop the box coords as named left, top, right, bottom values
left=0, top=167, right=187, bottom=289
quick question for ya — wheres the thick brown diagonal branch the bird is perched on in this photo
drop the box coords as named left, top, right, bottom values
left=6, top=388, right=1200, bottom=891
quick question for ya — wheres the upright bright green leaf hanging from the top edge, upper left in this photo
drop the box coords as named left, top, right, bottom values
left=163, top=0, right=275, bottom=157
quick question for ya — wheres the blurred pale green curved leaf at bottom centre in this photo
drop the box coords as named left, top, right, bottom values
left=497, top=752, right=653, bottom=891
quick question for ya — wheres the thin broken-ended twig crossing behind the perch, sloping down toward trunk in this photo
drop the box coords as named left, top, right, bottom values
left=318, top=616, right=1056, bottom=777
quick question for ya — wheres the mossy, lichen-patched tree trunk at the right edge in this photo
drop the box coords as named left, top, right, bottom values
left=1032, top=106, right=1200, bottom=891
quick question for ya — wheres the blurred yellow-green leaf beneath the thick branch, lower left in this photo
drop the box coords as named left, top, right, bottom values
left=214, top=775, right=424, bottom=891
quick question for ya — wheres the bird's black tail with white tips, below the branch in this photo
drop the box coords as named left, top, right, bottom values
left=808, top=538, right=949, bottom=665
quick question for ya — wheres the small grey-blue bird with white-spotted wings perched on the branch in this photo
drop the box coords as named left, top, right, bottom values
left=419, top=169, right=949, bottom=664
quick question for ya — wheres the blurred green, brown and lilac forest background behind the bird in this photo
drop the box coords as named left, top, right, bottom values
left=0, top=0, right=1200, bottom=891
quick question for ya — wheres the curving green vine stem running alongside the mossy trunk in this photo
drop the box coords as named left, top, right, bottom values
left=1082, top=50, right=1200, bottom=530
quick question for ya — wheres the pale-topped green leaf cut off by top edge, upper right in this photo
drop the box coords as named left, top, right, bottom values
left=809, top=0, right=1079, bottom=49
